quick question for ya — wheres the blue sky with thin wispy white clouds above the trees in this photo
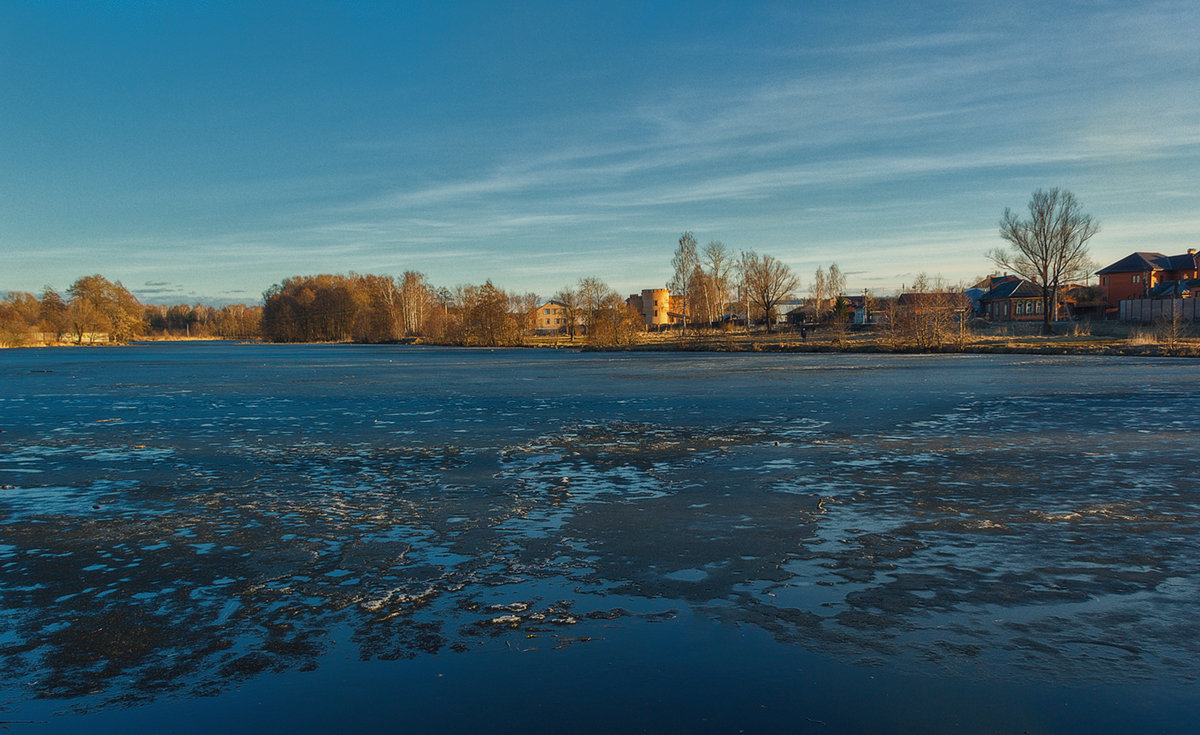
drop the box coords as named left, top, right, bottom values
left=0, top=0, right=1200, bottom=304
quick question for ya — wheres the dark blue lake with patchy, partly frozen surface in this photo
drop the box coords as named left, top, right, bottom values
left=0, top=345, right=1200, bottom=733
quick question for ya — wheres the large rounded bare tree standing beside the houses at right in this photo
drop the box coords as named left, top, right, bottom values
left=988, top=189, right=1100, bottom=334
